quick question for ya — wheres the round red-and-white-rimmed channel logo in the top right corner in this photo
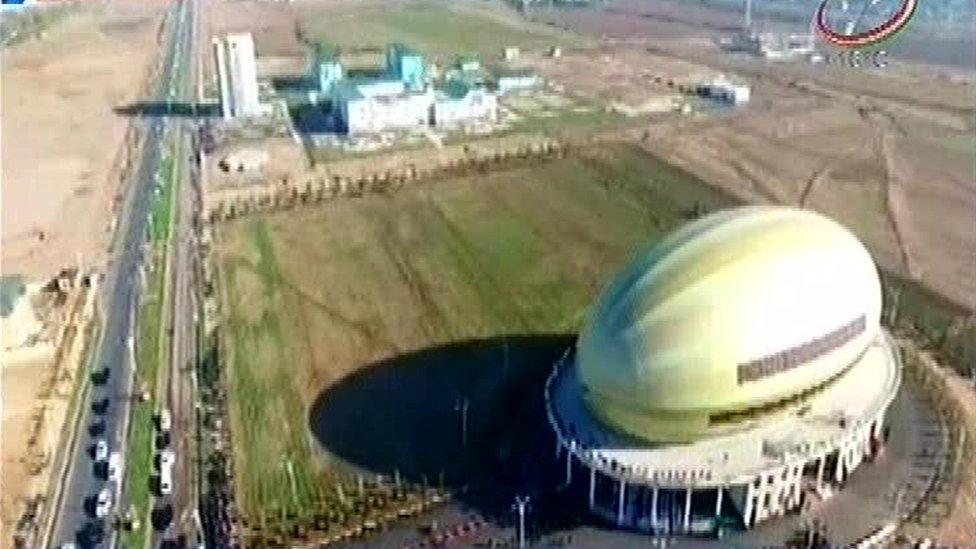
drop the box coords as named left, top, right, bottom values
left=813, top=0, right=918, bottom=49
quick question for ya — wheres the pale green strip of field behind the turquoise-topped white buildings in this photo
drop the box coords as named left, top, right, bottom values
left=295, top=0, right=578, bottom=57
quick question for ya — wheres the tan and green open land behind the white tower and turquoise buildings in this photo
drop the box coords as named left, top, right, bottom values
left=203, top=0, right=586, bottom=85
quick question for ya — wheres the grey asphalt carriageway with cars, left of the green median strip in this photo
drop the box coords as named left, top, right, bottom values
left=51, top=0, right=192, bottom=547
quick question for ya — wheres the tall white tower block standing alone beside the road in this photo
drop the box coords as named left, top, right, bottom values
left=213, top=33, right=264, bottom=119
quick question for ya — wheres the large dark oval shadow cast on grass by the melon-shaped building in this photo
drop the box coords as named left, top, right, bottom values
left=309, top=334, right=583, bottom=526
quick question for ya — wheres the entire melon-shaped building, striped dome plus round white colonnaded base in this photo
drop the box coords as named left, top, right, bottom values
left=545, top=206, right=901, bottom=534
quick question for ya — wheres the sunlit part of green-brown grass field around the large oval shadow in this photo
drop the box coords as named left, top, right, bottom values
left=218, top=141, right=721, bottom=532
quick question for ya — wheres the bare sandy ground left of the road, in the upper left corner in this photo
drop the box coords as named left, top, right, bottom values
left=2, top=1, right=165, bottom=280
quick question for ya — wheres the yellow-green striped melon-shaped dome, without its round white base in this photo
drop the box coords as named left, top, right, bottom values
left=576, top=206, right=881, bottom=440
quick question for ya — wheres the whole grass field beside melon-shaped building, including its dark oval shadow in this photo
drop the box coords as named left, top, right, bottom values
left=218, top=145, right=976, bottom=544
